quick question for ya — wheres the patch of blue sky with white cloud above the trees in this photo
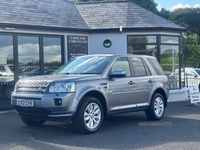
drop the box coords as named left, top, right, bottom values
left=154, top=0, right=200, bottom=11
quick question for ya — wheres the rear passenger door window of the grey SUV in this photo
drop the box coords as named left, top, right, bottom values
left=131, top=57, right=146, bottom=76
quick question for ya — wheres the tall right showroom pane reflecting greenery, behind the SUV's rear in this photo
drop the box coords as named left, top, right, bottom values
left=160, top=36, right=180, bottom=89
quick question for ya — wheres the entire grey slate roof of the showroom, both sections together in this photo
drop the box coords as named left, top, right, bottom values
left=0, top=0, right=184, bottom=30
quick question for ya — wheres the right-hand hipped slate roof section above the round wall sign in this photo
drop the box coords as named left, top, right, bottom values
left=76, top=1, right=183, bottom=29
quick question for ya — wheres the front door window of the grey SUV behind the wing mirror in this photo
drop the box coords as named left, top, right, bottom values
left=112, top=57, right=131, bottom=77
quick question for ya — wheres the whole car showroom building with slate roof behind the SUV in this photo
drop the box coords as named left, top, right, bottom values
left=0, top=0, right=186, bottom=107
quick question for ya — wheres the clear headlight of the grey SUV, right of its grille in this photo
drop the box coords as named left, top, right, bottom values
left=49, top=82, right=76, bottom=93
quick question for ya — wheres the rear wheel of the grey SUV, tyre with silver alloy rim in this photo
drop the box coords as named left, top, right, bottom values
left=145, top=93, right=165, bottom=120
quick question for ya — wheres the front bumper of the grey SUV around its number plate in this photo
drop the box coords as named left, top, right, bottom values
left=11, top=93, right=78, bottom=121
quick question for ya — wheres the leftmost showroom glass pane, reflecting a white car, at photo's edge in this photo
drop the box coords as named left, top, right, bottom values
left=0, top=35, right=14, bottom=101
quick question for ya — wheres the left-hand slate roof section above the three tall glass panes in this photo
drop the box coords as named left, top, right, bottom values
left=0, top=0, right=88, bottom=29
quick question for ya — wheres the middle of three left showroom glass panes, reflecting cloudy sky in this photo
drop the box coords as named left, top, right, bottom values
left=18, top=36, right=40, bottom=77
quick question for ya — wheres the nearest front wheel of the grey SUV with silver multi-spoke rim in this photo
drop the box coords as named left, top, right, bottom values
left=73, top=97, right=104, bottom=134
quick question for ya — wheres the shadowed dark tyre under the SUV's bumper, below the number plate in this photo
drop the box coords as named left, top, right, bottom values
left=21, top=117, right=46, bottom=126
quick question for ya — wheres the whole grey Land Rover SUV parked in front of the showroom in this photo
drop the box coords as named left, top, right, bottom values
left=11, top=54, right=169, bottom=133
